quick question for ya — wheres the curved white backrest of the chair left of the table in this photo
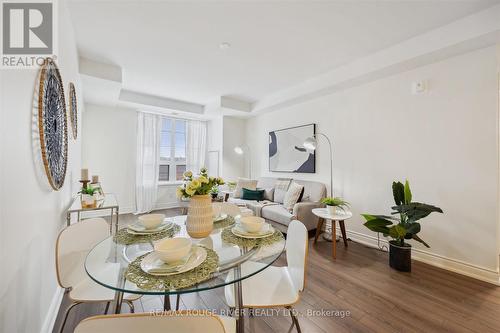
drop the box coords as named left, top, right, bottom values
left=56, top=218, right=109, bottom=288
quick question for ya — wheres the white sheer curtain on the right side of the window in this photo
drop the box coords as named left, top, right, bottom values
left=186, top=120, right=207, bottom=174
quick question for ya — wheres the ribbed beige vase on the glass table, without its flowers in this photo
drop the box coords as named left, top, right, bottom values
left=186, top=194, right=214, bottom=238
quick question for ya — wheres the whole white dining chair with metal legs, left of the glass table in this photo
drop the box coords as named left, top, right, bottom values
left=56, top=218, right=141, bottom=332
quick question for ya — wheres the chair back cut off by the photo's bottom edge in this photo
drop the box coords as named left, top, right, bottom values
left=74, top=310, right=236, bottom=333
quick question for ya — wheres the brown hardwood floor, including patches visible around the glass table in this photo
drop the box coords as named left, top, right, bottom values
left=54, top=210, right=500, bottom=333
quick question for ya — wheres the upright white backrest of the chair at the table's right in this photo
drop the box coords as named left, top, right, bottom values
left=286, top=220, right=308, bottom=292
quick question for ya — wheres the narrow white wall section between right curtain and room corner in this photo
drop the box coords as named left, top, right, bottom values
left=222, top=116, right=246, bottom=181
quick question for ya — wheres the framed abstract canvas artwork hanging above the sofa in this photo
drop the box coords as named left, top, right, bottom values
left=269, top=124, right=316, bottom=173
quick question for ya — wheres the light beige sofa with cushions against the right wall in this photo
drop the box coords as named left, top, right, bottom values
left=228, top=177, right=326, bottom=232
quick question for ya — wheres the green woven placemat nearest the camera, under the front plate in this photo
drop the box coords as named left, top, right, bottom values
left=125, top=247, right=219, bottom=291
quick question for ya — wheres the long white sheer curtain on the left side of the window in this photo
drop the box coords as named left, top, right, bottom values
left=135, top=112, right=161, bottom=214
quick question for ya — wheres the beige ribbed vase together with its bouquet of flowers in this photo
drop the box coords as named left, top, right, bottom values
left=177, top=168, right=224, bottom=238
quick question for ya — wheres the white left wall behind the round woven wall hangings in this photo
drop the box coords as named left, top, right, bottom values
left=0, top=1, right=83, bottom=333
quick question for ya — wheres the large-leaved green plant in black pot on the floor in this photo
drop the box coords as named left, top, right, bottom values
left=362, top=181, right=443, bottom=272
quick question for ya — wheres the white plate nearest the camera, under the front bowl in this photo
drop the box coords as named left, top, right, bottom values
left=141, top=245, right=207, bottom=276
